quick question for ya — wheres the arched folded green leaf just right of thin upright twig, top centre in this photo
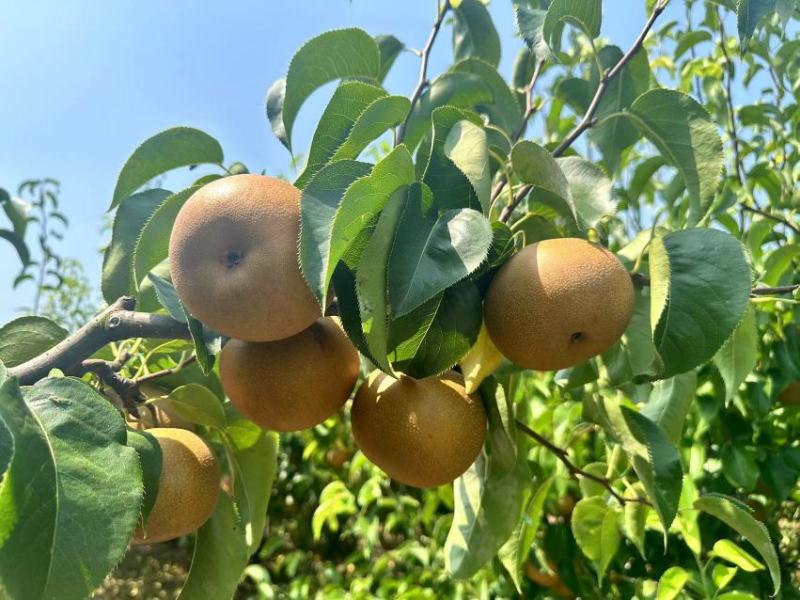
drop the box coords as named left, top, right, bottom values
left=400, top=72, right=494, bottom=152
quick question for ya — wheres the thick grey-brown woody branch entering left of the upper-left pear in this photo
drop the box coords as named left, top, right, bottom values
left=9, top=296, right=191, bottom=385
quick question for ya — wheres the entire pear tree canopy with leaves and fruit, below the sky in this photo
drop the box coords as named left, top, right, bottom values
left=0, top=0, right=800, bottom=600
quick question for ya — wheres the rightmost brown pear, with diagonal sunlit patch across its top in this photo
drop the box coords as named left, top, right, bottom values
left=484, top=238, right=634, bottom=371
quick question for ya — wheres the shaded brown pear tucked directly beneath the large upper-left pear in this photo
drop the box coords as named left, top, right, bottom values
left=219, top=317, right=360, bottom=431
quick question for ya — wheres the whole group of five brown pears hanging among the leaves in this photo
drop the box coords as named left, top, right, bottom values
left=136, top=174, right=634, bottom=543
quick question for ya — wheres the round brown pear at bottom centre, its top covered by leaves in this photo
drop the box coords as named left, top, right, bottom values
left=351, top=371, right=486, bottom=488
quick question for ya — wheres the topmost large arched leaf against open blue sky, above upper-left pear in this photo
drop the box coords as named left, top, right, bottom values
left=267, top=29, right=381, bottom=152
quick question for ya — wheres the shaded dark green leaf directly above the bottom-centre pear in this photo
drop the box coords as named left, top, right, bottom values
left=388, top=281, right=483, bottom=379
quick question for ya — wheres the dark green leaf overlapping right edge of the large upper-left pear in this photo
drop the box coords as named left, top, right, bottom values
left=300, top=160, right=371, bottom=303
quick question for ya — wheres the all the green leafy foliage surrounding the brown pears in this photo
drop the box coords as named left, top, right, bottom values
left=0, top=0, right=800, bottom=598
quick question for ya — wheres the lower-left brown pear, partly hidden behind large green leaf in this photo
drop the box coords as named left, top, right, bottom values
left=133, top=427, right=220, bottom=544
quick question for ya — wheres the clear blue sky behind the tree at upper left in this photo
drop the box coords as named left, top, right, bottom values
left=0, top=0, right=664, bottom=323
